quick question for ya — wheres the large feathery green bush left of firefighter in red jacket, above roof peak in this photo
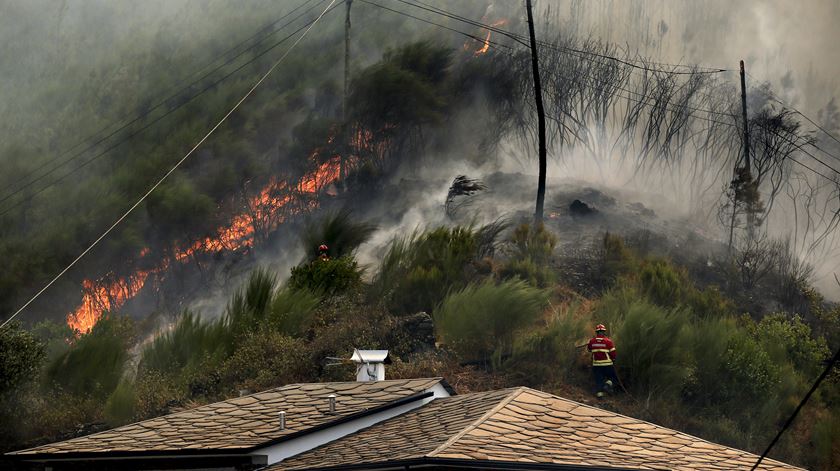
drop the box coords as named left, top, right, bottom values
left=434, top=280, right=548, bottom=366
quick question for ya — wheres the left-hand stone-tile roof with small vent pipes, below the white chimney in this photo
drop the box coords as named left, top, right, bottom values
left=9, top=378, right=449, bottom=459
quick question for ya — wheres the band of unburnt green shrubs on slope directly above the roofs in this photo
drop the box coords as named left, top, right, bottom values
left=0, top=220, right=840, bottom=469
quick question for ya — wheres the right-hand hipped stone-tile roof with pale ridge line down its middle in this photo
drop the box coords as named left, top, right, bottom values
left=269, top=388, right=801, bottom=471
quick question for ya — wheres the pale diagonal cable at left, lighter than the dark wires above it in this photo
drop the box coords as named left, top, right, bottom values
left=0, top=0, right=337, bottom=328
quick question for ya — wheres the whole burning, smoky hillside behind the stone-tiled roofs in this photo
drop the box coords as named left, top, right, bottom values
left=0, top=0, right=840, bottom=470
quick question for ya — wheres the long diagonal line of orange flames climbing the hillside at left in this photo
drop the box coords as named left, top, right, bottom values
left=67, top=155, right=344, bottom=333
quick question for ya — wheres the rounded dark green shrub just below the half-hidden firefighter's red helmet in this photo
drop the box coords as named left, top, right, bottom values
left=288, top=256, right=362, bottom=295
